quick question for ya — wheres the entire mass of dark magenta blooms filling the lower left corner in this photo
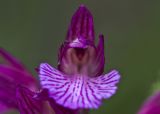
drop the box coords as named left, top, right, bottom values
left=0, top=48, right=78, bottom=114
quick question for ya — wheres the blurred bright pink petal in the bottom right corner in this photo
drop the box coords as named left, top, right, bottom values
left=137, top=91, right=160, bottom=114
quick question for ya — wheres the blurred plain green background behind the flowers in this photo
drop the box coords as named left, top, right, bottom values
left=0, top=0, right=160, bottom=114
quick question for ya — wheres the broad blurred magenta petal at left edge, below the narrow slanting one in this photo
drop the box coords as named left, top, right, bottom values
left=0, top=65, right=36, bottom=112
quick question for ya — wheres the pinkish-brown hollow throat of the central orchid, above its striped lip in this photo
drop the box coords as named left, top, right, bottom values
left=60, top=46, right=96, bottom=75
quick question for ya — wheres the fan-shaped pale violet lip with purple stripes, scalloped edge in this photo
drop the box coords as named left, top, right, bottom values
left=40, top=63, right=120, bottom=109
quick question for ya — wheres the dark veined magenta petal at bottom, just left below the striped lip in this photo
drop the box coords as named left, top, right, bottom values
left=16, top=86, right=54, bottom=114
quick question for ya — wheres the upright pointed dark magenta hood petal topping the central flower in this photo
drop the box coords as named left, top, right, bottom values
left=67, top=5, right=94, bottom=42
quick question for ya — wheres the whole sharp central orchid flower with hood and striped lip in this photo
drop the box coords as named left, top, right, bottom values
left=39, top=5, right=120, bottom=109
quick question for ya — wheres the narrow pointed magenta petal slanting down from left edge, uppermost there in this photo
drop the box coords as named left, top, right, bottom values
left=0, top=48, right=25, bottom=70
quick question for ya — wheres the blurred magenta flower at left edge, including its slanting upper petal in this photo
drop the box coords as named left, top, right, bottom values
left=0, top=48, right=37, bottom=112
